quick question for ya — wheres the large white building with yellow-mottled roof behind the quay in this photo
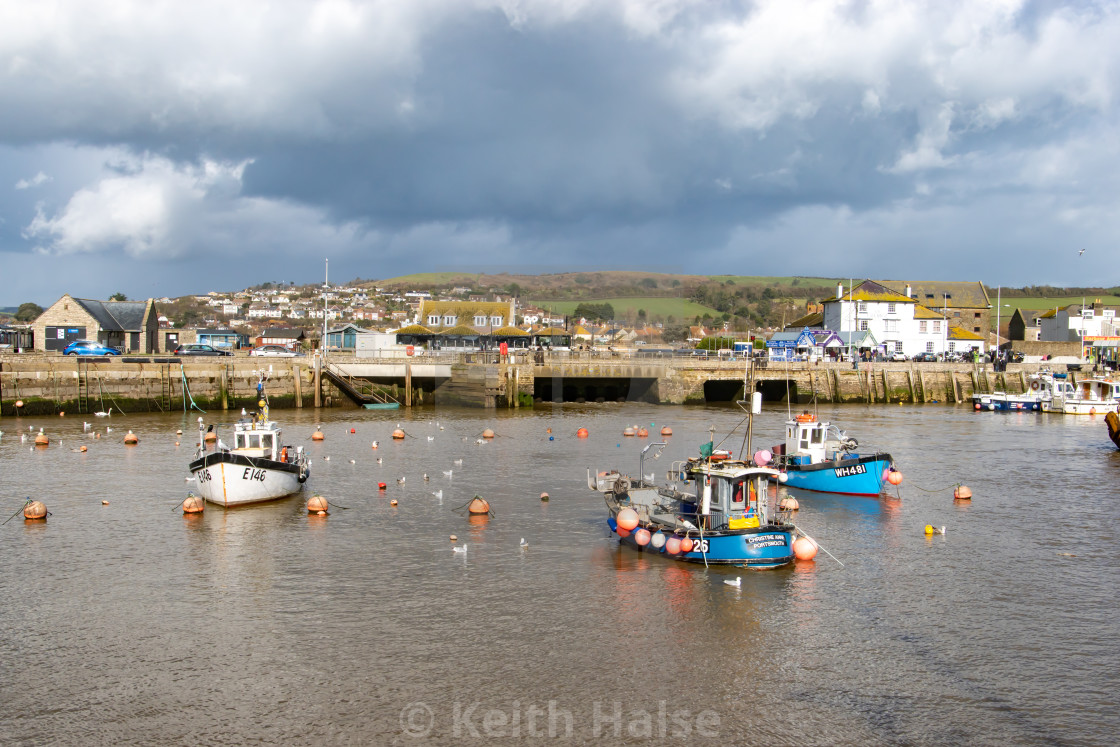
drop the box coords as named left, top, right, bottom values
left=823, top=280, right=967, bottom=357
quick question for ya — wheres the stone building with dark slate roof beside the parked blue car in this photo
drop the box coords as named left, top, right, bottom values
left=31, top=293, right=159, bottom=353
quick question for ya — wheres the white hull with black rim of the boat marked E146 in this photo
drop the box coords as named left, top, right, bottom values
left=189, top=451, right=307, bottom=507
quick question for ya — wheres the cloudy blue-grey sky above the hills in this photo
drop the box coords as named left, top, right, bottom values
left=0, top=0, right=1120, bottom=306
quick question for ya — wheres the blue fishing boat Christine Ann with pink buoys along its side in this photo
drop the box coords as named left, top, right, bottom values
left=587, top=443, right=797, bottom=568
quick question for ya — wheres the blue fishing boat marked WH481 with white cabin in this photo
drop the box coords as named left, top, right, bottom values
left=767, top=411, right=902, bottom=495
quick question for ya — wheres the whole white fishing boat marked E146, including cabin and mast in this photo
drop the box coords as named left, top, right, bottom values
left=189, top=380, right=311, bottom=507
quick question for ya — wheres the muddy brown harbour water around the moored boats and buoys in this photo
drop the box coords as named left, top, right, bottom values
left=0, top=403, right=1120, bottom=745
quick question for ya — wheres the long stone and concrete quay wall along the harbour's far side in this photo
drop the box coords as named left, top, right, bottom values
left=0, top=354, right=1081, bottom=417
